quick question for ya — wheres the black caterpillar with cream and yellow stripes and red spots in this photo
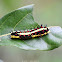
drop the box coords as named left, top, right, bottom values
left=11, top=25, right=50, bottom=39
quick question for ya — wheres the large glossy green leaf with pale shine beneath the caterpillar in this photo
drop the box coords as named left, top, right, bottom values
left=0, top=5, right=62, bottom=50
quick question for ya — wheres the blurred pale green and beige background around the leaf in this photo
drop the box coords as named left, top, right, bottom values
left=0, top=0, right=62, bottom=62
